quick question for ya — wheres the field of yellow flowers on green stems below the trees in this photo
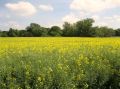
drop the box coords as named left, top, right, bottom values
left=0, top=37, right=120, bottom=89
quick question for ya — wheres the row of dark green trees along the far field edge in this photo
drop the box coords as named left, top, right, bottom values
left=0, top=18, right=120, bottom=37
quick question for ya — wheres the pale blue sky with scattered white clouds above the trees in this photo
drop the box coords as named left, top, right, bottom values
left=0, top=0, right=120, bottom=30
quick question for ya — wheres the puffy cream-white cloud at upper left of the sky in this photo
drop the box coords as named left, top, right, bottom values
left=5, top=1, right=37, bottom=16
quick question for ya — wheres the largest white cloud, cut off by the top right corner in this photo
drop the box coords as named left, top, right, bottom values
left=70, top=0, right=120, bottom=12
